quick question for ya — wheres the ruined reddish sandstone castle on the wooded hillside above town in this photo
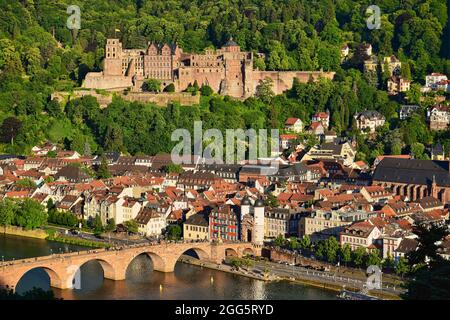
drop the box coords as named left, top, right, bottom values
left=83, top=39, right=334, bottom=98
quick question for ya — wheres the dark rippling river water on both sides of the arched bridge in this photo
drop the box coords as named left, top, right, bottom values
left=0, top=235, right=336, bottom=300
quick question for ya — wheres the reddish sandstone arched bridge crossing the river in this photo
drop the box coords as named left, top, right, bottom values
left=0, top=242, right=262, bottom=289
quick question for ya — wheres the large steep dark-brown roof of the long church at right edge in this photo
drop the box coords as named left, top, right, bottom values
left=373, top=158, right=450, bottom=187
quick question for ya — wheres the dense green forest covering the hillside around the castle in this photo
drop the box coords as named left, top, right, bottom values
left=0, top=0, right=450, bottom=161
